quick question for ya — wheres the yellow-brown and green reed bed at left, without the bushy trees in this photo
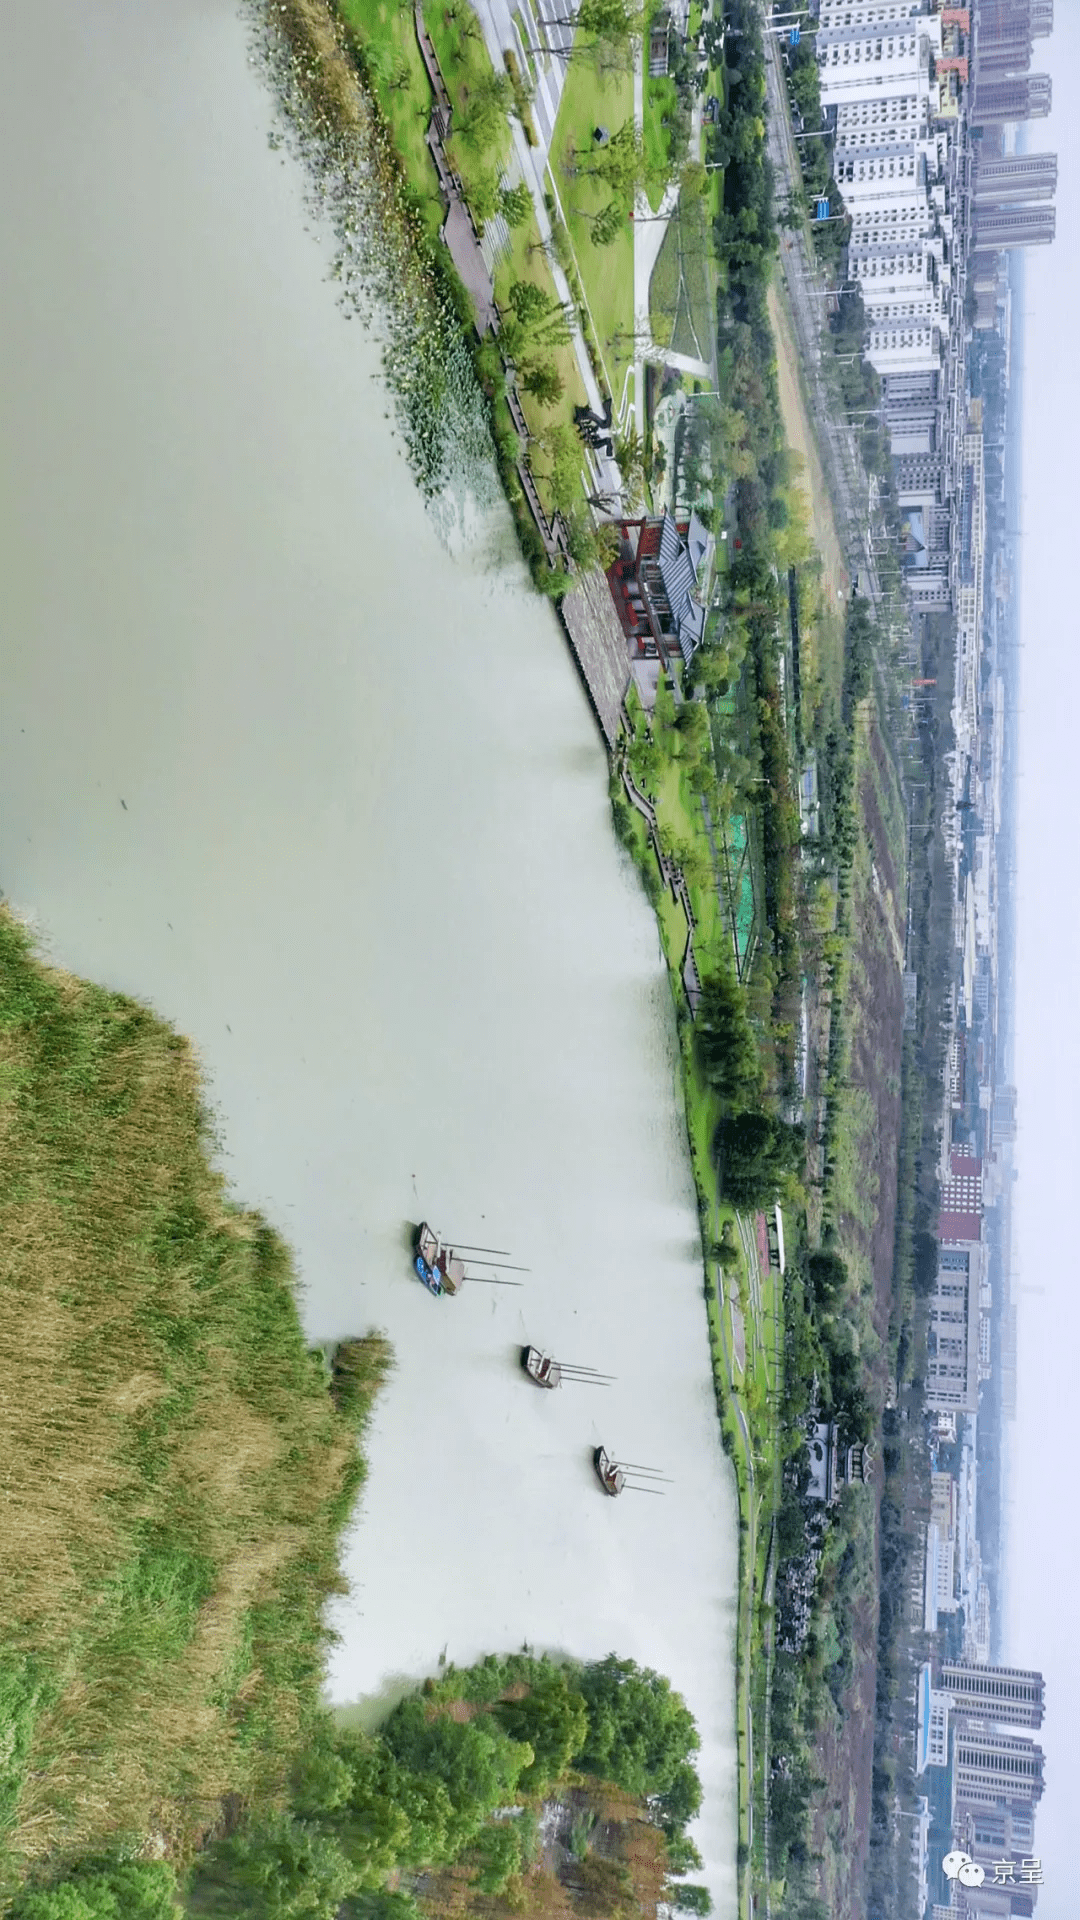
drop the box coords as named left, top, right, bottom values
left=0, top=910, right=388, bottom=1872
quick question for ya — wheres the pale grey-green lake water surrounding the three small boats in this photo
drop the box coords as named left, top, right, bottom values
left=0, top=0, right=738, bottom=1910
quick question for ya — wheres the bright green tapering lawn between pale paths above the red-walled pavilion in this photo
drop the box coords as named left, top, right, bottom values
left=550, top=58, right=634, bottom=403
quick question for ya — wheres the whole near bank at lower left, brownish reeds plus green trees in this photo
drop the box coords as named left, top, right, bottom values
left=0, top=904, right=711, bottom=1920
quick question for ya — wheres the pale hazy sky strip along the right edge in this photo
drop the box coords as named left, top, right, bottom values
left=1003, top=11, right=1080, bottom=1920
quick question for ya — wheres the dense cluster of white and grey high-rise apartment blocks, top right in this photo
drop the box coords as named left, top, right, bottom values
left=815, top=0, right=1057, bottom=629
